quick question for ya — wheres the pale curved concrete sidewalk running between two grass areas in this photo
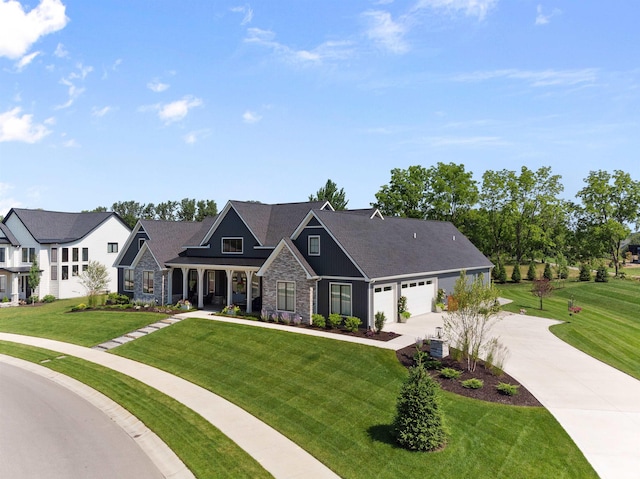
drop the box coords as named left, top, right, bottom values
left=0, top=333, right=339, bottom=479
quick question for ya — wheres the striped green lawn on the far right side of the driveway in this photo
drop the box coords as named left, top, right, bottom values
left=498, top=278, right=640, bottom=379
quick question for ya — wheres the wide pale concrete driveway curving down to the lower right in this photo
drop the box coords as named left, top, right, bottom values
left=386, top=313, right=640, bottom=479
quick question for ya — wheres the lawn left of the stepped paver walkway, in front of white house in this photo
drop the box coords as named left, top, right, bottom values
left=0, top=298, right=166, bottom=346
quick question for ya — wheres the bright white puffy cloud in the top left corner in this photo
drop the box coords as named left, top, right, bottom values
left=0, top=0, right=69, bottom=59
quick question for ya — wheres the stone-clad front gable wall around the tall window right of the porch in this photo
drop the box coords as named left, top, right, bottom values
left=262, top=248, right=316, bottom=324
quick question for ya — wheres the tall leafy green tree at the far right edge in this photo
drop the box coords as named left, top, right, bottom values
left=576, top=170, right=640, bottom=276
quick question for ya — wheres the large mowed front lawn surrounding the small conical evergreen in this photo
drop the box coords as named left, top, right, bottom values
left=114, top=319, right=596, bottom=478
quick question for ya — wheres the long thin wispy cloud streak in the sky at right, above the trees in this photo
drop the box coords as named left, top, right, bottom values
left=453, top=68, right=598, bottom=87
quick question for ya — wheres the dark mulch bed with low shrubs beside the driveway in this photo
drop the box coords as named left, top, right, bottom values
left=396, top=344, right=542, bottom=406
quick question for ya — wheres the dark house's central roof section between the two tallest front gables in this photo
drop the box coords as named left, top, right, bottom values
left=230, top=201, right=327, bottom=247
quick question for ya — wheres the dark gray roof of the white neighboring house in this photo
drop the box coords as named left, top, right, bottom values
left=3, top=208, right=125, bottom=244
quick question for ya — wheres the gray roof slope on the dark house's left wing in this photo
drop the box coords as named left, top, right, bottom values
left=140, top=220, right=210, bottom=266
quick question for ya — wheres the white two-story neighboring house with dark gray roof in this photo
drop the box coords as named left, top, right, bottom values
left=0, top=208, right=131, bottom=302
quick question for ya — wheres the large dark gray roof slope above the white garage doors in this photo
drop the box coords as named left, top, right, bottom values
left=314, top=210, right=492, bottom=279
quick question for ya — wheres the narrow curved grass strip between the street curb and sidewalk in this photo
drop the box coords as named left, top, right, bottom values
left=0, top=341, right=271, bottom=479
